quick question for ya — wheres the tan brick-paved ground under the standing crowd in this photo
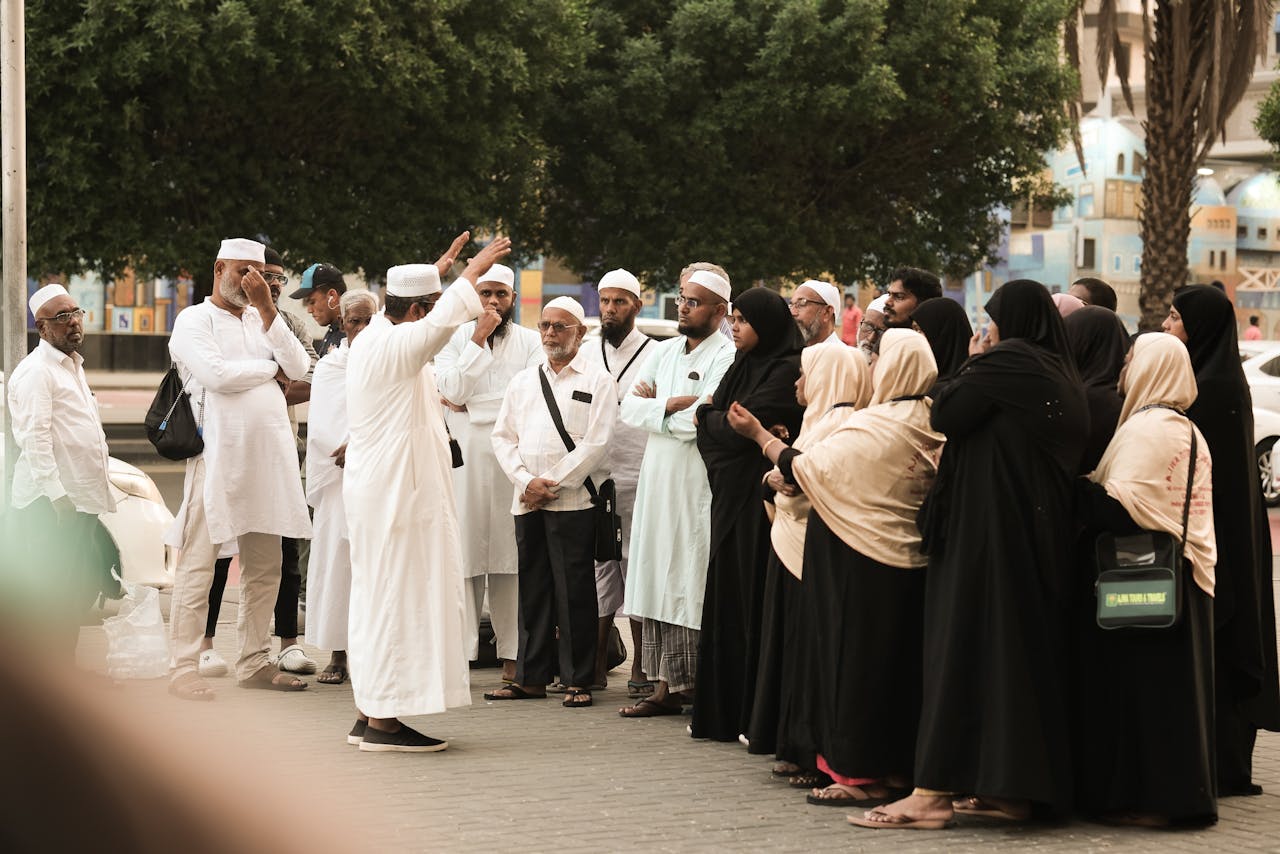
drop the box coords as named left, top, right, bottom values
left=81, top=603, right=1280, bottom=854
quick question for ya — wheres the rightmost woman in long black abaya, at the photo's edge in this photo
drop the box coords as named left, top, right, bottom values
left=1164, top=284, right=1280, bottom=798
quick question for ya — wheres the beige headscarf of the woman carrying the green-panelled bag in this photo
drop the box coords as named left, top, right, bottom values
left=1089, top=333, right=1217, bottom=595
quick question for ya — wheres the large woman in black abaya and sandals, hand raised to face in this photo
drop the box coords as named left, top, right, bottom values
left=850, top=279, right=1088, bottom=830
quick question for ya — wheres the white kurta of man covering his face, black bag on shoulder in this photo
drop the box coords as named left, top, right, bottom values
left=165, top=300, right=311, bottom=548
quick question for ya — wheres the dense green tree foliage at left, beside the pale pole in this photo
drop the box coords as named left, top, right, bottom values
left=27, top=0, right=584, bottom=281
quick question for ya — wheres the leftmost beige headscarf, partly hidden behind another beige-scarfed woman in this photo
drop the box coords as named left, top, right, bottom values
left=765, top=344, right=872, bottom=579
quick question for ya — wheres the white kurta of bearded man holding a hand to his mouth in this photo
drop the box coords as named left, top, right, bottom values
left=435, top=323, right=545, bottom=579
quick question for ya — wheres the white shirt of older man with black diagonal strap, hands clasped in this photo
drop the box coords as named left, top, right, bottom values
left=493, top=351, right=618, bottom=516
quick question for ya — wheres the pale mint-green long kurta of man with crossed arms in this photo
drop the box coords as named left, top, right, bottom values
left=621, top=334, right=736, bottom=629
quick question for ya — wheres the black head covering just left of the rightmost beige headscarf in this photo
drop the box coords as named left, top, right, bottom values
left=1062, top=306, right=1129, bottom=475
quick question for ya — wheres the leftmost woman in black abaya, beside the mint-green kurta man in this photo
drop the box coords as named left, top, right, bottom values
left=692, top=288, right=804, bottom=741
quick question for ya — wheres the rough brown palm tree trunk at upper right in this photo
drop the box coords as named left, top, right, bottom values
left=1138, top=3, right=1197, bottom=332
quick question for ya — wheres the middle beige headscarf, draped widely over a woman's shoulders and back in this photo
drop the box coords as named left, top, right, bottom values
left=791, top=329, right=945, bottom=568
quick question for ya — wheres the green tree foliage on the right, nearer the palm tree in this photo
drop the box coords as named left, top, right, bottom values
left=544, top=0, right=1075, bottom=286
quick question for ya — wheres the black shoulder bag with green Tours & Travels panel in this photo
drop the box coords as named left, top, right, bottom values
left=1094, top=410, right=1197, bottom=629
